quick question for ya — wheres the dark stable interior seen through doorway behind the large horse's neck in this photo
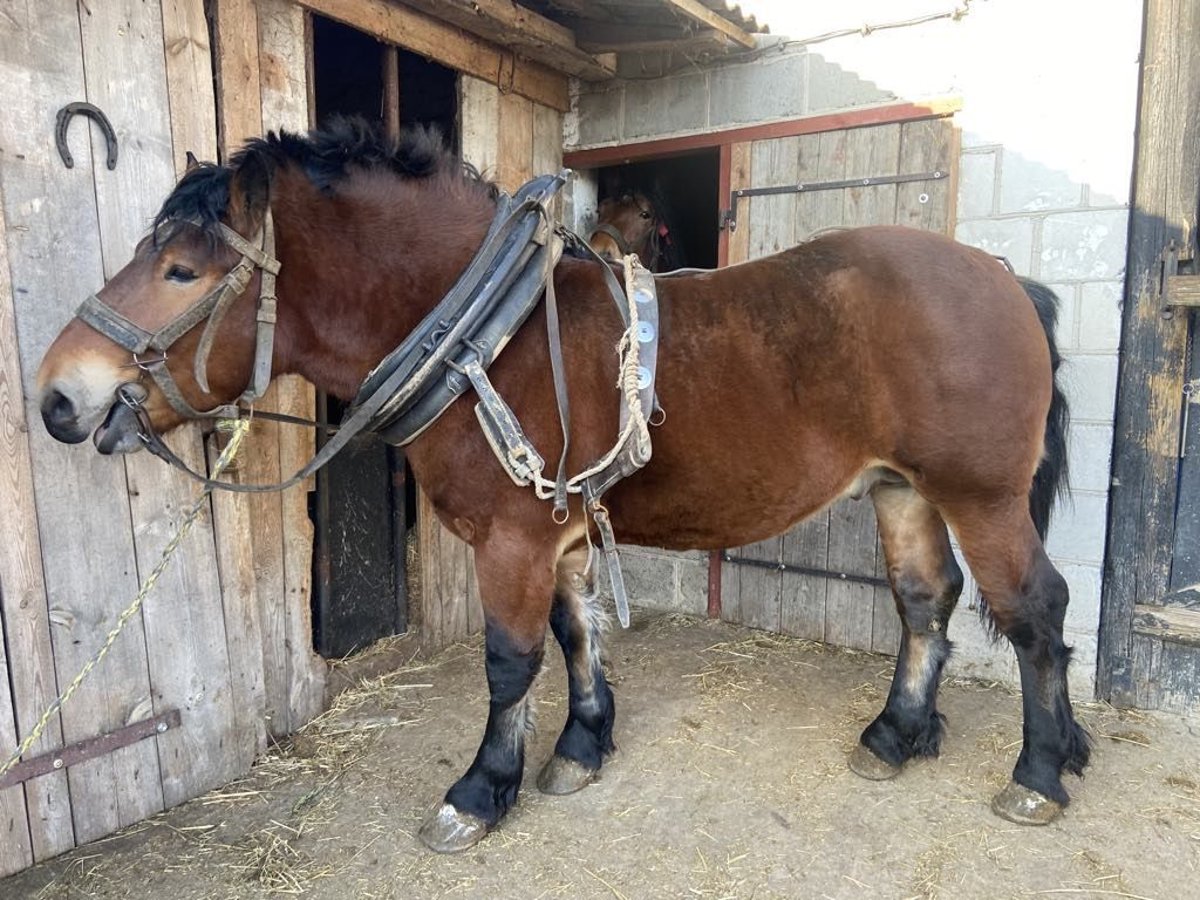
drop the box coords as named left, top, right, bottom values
left=310, top=16, right=458, bottom=658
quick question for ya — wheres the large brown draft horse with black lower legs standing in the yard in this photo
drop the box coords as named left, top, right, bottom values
left=38, top=125, right=1088, bottom=851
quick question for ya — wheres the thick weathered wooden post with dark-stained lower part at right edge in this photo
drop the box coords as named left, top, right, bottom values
left=1097, top=0, right=1200, bottom=706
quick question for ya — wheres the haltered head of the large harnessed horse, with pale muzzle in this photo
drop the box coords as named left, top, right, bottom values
left=37, top=154, right=277, bottom=454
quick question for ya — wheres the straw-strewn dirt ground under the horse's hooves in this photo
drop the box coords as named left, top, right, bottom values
left=0, top=611, right=1200, bottom=900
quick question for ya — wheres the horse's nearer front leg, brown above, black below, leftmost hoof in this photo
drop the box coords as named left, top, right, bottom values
left=420, top=533, right=554, bottom=853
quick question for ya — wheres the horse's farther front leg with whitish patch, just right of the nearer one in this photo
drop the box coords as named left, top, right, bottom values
left=538, top=550, right=614, bottom=794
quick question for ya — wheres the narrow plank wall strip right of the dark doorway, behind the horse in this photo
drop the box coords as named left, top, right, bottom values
left=409, top=74, right=563, bottom=648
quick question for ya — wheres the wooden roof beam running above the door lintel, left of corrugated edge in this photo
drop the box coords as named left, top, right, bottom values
left=403, top=0, right=617, bottom=82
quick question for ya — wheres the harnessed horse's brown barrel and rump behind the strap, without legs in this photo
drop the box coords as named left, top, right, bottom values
left=600, top=227, right=1051, bottom=545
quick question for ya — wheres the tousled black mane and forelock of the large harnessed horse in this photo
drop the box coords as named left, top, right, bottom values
left=154, top=118, right=497, bottom=242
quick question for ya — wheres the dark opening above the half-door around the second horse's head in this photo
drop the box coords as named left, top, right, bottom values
left=596, top=148, right=720, bottom=269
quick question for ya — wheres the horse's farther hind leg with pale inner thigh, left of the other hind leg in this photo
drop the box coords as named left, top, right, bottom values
left=850, top=484, right=962, bottom=780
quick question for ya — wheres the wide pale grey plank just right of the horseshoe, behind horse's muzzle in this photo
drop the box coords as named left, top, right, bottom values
left=80, top=0, right=241, bottom=806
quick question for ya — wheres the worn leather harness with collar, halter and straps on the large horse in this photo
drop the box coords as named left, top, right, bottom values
left=77, top=172, right=661, bottom=626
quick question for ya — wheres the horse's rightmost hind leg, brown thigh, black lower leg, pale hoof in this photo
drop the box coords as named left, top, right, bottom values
left=942, top=497, right=1088, bottom=824
